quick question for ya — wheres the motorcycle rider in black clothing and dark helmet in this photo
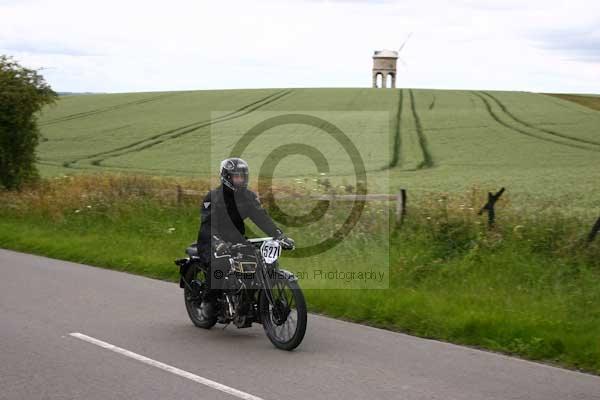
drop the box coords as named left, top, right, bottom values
left=197, top=158, right=294, bottom=317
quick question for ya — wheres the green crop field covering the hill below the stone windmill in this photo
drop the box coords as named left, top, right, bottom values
left=38, top=89, right=600, bottom=212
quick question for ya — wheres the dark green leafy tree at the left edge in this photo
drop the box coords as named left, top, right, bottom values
left=0, top=55, right=58, bottom=190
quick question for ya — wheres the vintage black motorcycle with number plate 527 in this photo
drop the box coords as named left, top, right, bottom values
left=175, top=237, right=307, bottom=350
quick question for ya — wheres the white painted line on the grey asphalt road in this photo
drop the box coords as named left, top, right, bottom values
left=69, top=332, right=263, bottom=400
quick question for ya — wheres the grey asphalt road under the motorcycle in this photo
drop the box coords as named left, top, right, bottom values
left=0, top=249, right=600, bottom=400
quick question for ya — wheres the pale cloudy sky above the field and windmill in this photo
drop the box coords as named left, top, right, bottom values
left=0, top=0, right=600, bottom=93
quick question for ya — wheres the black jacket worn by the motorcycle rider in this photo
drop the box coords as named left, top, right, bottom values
left=198, top=185, right=282, bottom=253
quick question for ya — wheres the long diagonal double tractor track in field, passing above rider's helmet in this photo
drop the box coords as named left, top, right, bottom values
left=63, top=89, right=292, bottom=168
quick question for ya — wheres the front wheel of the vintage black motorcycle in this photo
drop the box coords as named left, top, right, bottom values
left=259, top=279, right=307, bottom=351
